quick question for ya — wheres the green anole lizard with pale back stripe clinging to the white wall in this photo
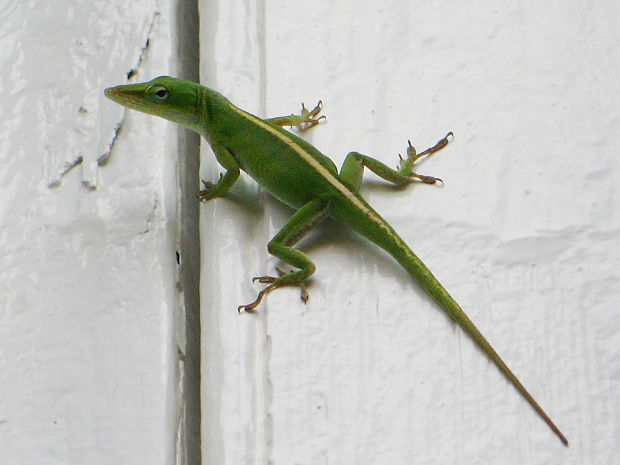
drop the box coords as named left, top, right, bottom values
left=105, top=76, right=568, bottom=446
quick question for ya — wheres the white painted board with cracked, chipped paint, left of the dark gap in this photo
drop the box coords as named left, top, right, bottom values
left=0, top=0, right=196, bottom=465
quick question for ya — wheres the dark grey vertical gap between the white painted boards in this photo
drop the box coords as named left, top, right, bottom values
left=173, top=0, right=201, bottom=465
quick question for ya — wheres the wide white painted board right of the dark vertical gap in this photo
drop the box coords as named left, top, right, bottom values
left=201, top=0, right=620, bottom=465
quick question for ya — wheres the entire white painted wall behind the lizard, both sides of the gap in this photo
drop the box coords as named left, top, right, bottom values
left=0, top=0, right=620, bottom=465
